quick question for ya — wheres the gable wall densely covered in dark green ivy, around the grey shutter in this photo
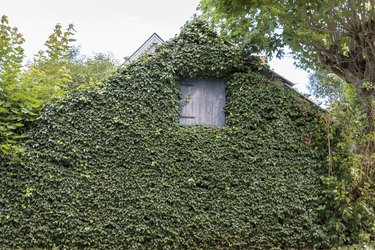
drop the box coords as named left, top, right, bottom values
left=0, top=19, right=327, bottom=249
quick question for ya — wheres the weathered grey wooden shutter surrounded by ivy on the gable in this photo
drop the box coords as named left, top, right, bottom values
left=180, top=79, right=225, bottom=126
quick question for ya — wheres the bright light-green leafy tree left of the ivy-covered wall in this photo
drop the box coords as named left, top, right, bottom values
left=0, top=16, right=77, bottom=160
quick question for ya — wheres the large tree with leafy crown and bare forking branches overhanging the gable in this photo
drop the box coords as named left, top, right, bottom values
left=200, top=0, right=375, bottom=153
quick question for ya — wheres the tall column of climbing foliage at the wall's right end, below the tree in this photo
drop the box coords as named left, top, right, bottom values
left=323, top=98, right=375, bottom=245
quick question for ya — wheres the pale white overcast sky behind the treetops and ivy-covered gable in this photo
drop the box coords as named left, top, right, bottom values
left=0, top=0, right=308, bottom=93
